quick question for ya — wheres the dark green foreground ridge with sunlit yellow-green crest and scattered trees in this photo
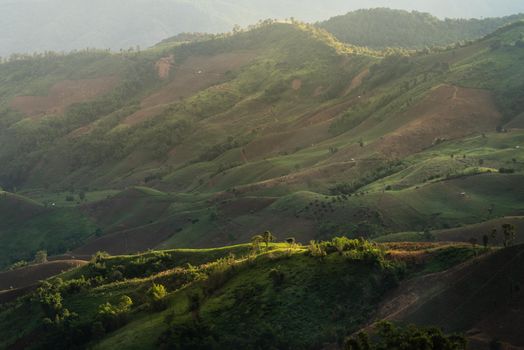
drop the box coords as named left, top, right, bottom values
left=0, top=239, right=488, bottom=349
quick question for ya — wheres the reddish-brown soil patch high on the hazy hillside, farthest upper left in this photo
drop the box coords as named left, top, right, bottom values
left=11, top=76, right=119, bottom=117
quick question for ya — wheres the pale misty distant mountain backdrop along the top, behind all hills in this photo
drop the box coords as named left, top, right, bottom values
left=0, top=0, right=524, bottom=57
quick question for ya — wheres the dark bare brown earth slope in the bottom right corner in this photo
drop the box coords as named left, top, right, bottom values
left=377, top=245, right=524, bottom=349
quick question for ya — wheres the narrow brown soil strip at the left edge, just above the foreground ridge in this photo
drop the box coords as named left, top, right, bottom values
left=0, top=260, right=87, bottom=290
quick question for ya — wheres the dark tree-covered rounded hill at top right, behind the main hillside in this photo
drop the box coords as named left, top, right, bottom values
left=318, top=8, right=524, bottom=49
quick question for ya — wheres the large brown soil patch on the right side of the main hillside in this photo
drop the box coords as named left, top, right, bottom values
left=371, top=85, right=501, bottom=158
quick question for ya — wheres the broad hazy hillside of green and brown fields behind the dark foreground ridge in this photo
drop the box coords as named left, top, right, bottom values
left=0, top=21, right=524, bottom=264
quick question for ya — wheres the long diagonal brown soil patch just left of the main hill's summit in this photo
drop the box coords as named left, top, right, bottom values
left=124, top=52, right=257, bottom=125
